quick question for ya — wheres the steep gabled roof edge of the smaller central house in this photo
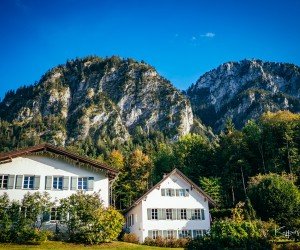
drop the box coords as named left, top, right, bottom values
left=123, top=168, right=217, bottom=214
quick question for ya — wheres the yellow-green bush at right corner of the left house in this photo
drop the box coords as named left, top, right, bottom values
left=60, top=192, right=124, bottom=244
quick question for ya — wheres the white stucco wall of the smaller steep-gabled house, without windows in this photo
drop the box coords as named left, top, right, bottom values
left=128, top=172, right=210, bottom=241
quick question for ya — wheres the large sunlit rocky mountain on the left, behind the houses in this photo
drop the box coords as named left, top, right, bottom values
left=0, top=56, right=197, bottom=146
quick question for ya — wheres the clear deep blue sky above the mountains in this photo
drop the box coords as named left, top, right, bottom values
left=0, top=0, right=300, bottom=98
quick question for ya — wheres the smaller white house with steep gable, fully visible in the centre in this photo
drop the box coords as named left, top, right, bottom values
left=124, top=169, right=216, bottom=242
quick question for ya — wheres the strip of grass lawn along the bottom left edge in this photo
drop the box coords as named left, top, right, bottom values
left=0, top=241, right=183, bottom=250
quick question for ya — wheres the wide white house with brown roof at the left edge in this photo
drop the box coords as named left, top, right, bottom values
left=0, top=144, right=118, bottom=207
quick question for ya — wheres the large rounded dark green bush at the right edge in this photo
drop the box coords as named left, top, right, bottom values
left=248, top=174, right=300, bottom=226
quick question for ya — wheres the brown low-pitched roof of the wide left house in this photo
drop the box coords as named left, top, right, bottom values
left=0, top=143, right=119, bottom=180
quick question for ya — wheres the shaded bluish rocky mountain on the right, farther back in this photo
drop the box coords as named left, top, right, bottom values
left=186, top=60, right=300, bottom=132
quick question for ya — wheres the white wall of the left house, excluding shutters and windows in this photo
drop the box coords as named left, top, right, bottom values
left=0, top=156, right=109, bottom=206
